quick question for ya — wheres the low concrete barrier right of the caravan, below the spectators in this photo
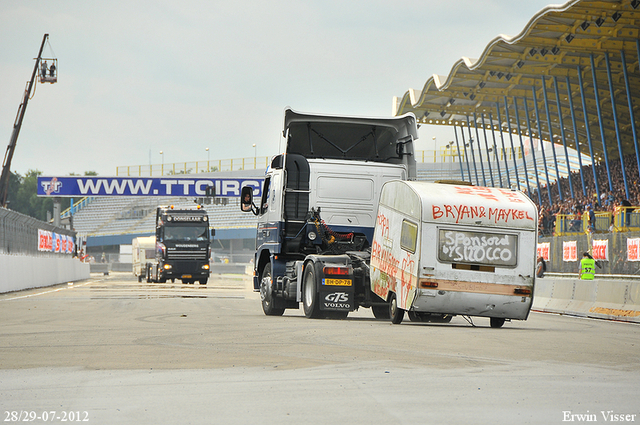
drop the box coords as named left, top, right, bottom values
left=533, top=277, right=640, bottom=323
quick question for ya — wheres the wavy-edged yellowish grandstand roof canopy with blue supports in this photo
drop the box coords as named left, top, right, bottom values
left=394, top=0, right=640, bottom=159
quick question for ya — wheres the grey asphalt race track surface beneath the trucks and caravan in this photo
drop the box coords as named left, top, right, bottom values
left=0, top=273, right=640, bottom=425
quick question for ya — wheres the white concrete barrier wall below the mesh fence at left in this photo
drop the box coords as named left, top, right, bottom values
left=0, top=254, right=89, bottom=293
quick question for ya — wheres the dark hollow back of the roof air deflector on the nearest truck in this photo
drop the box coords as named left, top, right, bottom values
left=287, top=122, right=402, bottom=163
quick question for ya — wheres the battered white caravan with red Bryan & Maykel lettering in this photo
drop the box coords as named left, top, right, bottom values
left=371, top=180, right=538, bottom=327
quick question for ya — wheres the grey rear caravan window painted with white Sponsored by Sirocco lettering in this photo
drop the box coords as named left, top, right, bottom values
left=438, top=229, right=518, bottom=266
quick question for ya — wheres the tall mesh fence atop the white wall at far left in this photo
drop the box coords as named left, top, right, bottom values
left=0, top=208, right=76, bottom=257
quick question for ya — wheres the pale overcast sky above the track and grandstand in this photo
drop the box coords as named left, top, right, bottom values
left=0, top=0, right=550, bottom=176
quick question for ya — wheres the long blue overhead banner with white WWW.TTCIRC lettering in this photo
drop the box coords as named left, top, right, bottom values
left=38, top=176, right=263, bottom=197
